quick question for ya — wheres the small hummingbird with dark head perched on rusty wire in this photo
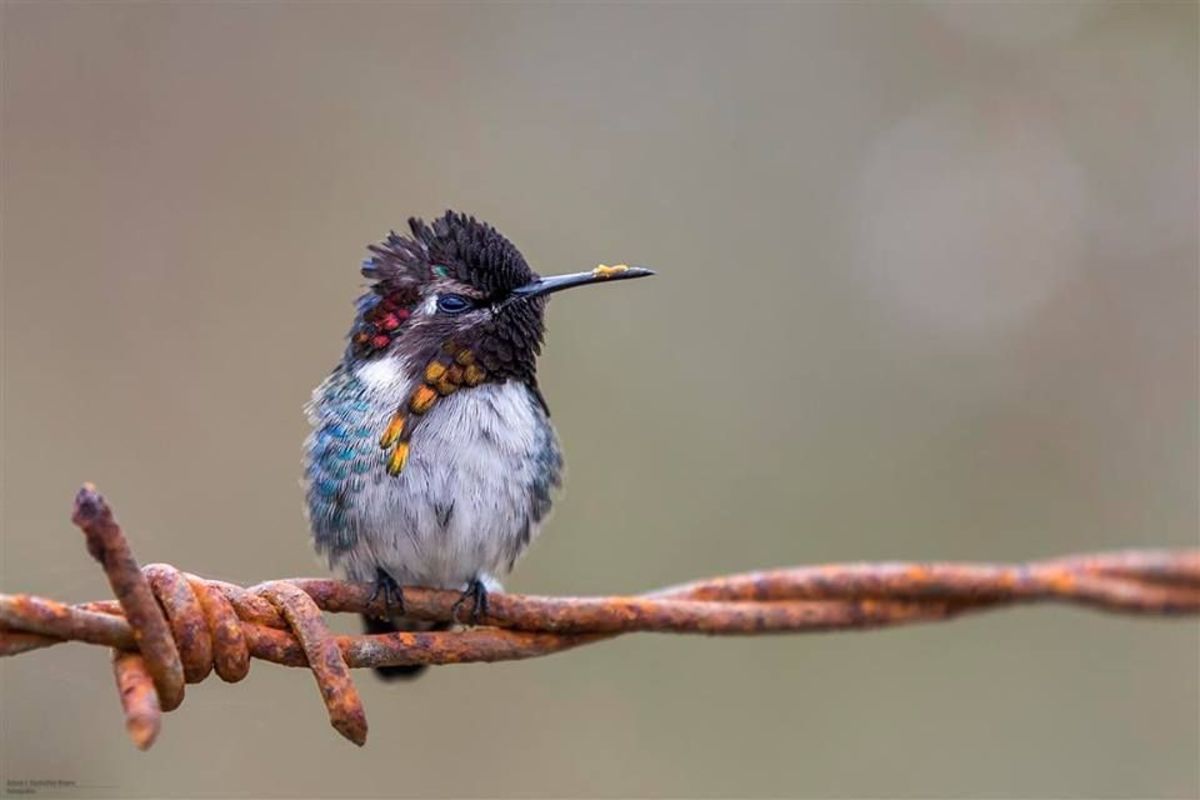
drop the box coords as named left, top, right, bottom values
left=304, top=211, right=654, bottom=679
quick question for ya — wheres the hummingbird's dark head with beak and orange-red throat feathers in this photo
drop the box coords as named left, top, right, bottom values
left=348, top=211, right=653, bottom=473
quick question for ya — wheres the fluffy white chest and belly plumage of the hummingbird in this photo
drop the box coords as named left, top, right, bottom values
left=332, top=361, right=562, bottom=588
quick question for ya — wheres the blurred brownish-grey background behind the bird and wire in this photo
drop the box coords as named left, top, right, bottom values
left=0, top=2, right=1200, bottom=798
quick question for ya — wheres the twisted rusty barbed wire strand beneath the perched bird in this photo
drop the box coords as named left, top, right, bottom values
left=0, top=485, right=1200, bottom=750
